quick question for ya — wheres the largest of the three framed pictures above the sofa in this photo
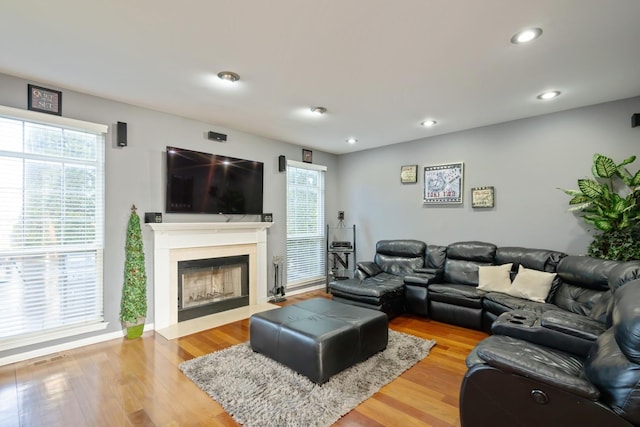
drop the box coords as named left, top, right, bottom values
left=423, top=162, right=464, bottom=205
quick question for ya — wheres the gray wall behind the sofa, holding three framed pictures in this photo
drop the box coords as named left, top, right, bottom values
left=338, top=95, right=640, bottom=261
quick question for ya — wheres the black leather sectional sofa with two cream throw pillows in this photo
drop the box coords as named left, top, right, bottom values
left=329, top=240, right=640, bottom=427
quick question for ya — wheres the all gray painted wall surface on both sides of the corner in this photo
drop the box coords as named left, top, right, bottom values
left=0, top=69, right=640, bottom=356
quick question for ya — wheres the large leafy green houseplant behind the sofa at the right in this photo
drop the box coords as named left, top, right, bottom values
left=561, top=153, right=640, bottom=261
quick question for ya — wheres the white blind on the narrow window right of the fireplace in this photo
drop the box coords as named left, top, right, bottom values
left=287, top=162, right=325, bottom=288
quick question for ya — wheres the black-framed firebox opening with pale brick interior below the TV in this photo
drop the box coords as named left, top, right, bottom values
left=178, top=255, right=249, bottom=322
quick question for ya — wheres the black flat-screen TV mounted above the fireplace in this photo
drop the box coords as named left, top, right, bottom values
left=166, top=147, right=264, bottom=215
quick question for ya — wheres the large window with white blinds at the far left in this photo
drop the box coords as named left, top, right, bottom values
left=0, top=107, right=107, bottom=349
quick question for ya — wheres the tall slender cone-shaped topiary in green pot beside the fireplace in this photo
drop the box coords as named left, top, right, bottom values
left=120, top=205, right=147, bottom=339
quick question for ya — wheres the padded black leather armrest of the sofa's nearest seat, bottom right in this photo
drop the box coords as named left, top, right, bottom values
left=476, top=335, right=600, bottom=400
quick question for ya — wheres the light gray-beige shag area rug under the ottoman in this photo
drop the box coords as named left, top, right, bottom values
left=179, top=330, right=436, bottom=427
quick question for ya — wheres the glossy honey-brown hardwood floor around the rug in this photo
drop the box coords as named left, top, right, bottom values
left=0, top=291, right=486, bottom=427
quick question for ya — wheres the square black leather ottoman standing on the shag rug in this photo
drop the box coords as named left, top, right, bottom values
left=249, top=298, right=389, bottom=384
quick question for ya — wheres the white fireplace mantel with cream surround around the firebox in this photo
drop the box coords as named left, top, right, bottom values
left=147, top=222, right=274, bottom=339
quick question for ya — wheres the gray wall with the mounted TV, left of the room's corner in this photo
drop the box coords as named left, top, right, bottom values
left=0, top=74, right=338, bottom=357
